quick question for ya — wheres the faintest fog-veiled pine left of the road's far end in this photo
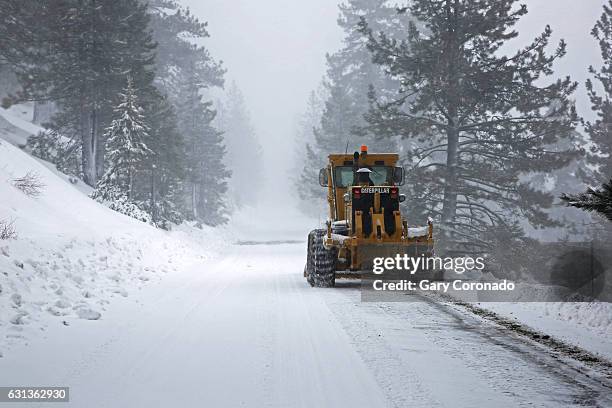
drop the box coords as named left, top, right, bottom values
left=218, top=82, right=264, bottom=207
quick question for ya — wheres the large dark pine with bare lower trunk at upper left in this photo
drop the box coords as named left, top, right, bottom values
left=4, top=0, right=155, bottom=186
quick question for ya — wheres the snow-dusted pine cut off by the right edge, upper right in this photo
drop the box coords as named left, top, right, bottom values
left=585, top=1, right=612, bottom=180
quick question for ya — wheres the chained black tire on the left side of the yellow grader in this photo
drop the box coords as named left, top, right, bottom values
left=307, top=229, right=338, bottom=288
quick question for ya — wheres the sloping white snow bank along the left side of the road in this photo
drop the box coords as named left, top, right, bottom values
left=0, top=141, right=223, bottom=354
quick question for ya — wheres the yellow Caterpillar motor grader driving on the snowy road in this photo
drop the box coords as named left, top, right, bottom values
left=304, top=146, right=434, bottom=287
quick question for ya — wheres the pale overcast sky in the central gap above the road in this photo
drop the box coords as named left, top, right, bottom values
left=182, top=0, right=342, bottom=184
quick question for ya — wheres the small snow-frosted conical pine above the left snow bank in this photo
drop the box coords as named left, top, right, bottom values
left=91, top=77, right=151, bottom=222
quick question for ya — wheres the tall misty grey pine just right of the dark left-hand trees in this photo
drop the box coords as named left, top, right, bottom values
left=149, top=0, right=229, bottom=225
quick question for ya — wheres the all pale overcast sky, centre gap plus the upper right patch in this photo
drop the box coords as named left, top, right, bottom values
left=183, top=0, right=604, bottom=171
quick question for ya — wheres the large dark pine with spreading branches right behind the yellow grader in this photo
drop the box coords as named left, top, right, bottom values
left=360, top=0, right=576, bottom=251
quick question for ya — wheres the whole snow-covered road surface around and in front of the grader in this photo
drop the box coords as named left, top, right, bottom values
left=0, top=243, right=612, bottom=408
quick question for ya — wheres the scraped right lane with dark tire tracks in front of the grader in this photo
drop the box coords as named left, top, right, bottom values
left=320, top=285, right=612, bottom=407
